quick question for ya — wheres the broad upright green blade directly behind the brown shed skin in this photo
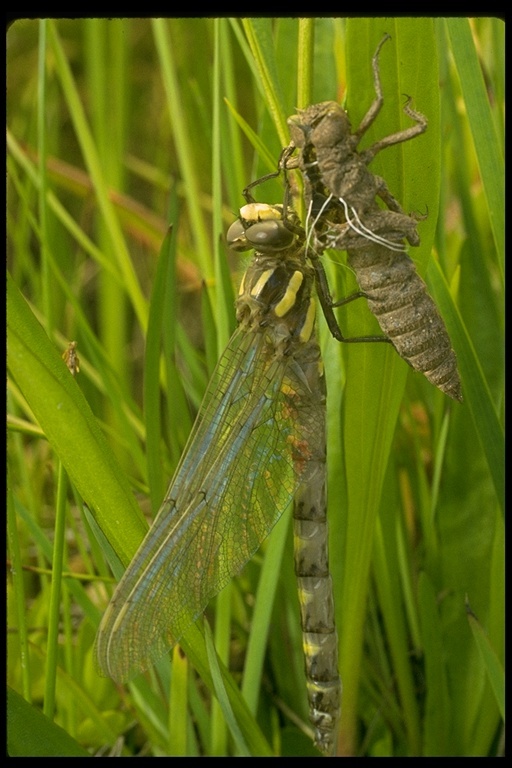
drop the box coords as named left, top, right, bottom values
left=338, top=19, right=439, bottom=744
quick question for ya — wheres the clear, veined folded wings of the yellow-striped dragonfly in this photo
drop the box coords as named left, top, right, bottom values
left=97, top=320, right=322, bottom=681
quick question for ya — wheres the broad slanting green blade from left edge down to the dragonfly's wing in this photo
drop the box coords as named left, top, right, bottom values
left=7, top=278, right=145, bottom=565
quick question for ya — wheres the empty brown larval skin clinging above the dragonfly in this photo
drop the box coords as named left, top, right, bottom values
left=281, top=35, right=462, bottom=401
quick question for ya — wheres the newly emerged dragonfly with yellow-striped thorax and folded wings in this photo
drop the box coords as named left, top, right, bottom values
left=96, top=185, right=341, bottom=755
